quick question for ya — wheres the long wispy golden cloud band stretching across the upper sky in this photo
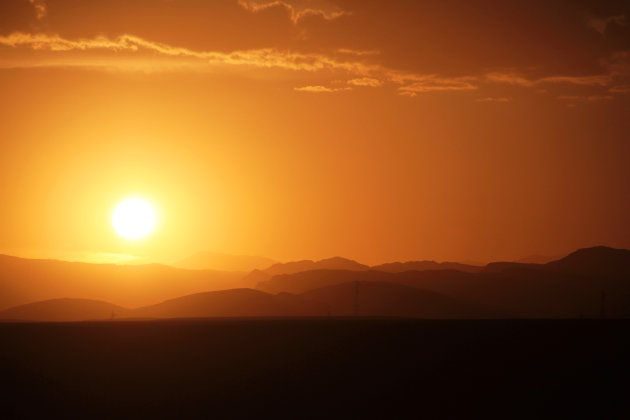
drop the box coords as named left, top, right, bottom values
left=0, top=32, right=629, bottom=96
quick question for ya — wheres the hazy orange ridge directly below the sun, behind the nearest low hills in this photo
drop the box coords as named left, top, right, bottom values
left=0, top=255, right=243, bottom=310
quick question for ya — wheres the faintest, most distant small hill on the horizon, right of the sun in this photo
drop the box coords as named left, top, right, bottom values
left=173, top=252, right=276, bottom=272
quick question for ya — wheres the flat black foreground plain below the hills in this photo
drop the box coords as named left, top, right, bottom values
left=0, top=318, right=630, bottom=419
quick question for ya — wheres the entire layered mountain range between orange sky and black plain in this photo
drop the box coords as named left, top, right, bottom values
left=0, top=247, right=630, bottom=321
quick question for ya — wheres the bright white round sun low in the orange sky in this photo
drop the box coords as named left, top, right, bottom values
left=112, top=198, right=156, bottom=239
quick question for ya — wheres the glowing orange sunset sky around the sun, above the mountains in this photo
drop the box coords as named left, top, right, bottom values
left=0, top=0, right=630, bottom=264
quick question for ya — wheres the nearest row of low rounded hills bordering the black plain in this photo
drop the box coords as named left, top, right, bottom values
left=0, top=282, right=492, bottom=322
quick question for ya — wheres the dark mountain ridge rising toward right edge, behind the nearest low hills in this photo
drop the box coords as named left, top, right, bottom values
left=258, top=247, right=630, bottom=318
